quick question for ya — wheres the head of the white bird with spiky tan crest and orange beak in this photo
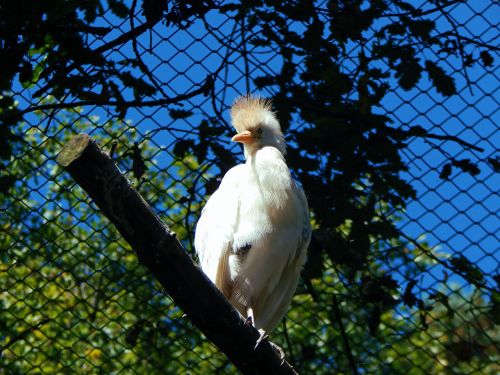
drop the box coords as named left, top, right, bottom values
left=231, top=95, right=286, bottom=157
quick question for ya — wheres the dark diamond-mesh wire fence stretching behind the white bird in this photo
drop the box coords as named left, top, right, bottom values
left=0, top=0, right=500, bottom=374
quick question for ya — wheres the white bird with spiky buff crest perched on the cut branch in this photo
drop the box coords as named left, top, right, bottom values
left=195, top=96, right=311, bottom=342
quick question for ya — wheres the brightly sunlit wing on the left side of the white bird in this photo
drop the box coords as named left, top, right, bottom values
left=195, top=165, right=244, bottom=296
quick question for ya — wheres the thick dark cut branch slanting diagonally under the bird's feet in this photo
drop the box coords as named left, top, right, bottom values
left=57, top=134, right=297, bottom=375
